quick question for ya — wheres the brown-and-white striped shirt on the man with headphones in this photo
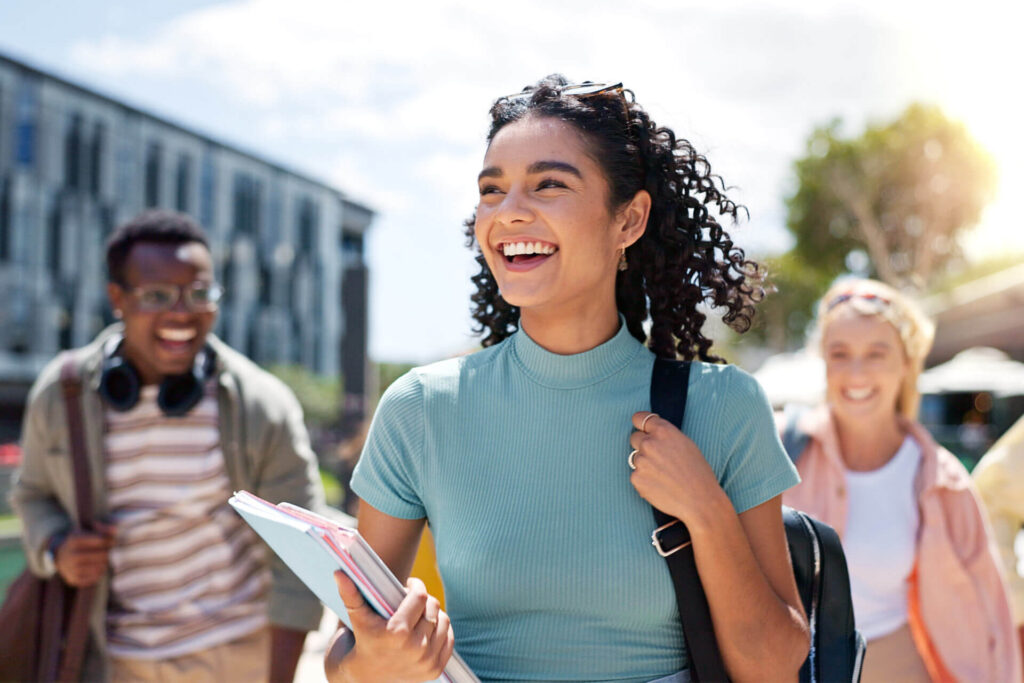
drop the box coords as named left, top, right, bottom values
left=104, top=382, right=270, bottom=659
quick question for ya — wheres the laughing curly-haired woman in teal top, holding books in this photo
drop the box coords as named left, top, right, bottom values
left=326, top=76, right=808, bottom=683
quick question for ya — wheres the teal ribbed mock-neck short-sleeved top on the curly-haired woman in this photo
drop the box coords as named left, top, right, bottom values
left=352, top=326, right=799, bottom=683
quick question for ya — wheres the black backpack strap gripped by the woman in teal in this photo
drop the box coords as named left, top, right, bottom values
left=650, top=358, right=729, bottom=683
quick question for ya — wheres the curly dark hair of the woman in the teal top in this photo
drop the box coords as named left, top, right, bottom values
left=465, top=74, right=765, bottom=362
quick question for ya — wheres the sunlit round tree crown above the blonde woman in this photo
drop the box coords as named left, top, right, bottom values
left=786, top=104, right=996, bottom=289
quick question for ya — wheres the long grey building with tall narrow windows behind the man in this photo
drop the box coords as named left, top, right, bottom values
left=0, top=49, right=373, bottom=442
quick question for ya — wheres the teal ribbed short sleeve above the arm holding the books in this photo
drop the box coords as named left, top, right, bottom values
left=351, top=371, right=426, bottom=519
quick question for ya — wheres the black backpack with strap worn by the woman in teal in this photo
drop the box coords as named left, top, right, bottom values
left=650, top=358, right=865, bottom=683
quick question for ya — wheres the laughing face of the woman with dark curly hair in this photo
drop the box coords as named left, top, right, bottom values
left=474, top=117, right=646, bottom=319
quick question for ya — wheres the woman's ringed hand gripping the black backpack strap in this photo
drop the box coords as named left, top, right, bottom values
left=630, top=411, right=723, bottom=525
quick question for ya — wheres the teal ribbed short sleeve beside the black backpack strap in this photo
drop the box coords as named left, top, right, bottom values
left=719, top=367, right=800, bottom=513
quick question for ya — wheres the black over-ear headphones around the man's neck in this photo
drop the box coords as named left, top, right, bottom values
left=99, top=335, right=217, bottom=418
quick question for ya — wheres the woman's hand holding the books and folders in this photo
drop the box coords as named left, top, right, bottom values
left=325, top=571, right=455, bottom=683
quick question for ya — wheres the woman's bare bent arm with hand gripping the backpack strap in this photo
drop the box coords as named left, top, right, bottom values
left=630, top=412, right=810, bottom=683
